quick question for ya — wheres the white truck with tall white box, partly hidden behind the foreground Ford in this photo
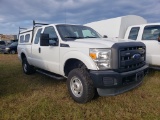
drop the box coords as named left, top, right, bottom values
left=85, top=15, right=160, bottom=69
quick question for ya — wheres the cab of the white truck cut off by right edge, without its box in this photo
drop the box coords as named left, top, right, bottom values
left=124, top=23, right=160, bottom=70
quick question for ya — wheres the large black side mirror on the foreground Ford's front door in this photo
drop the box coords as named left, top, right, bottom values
left=40, top=34, right=49, bottom=46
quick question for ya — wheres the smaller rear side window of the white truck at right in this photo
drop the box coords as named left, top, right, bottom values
left=128, top=27, right=139, bottom=40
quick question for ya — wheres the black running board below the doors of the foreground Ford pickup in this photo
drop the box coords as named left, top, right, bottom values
left=36, top=69, right=65, bottom=80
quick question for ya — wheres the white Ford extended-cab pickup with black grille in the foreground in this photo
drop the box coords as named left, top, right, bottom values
left=18, top=22, right=148, bottom=103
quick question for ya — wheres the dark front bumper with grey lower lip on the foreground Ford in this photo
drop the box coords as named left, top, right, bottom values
left=90, top=65, right=148, bottom=96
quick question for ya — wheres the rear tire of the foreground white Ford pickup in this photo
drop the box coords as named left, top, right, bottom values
left=22, top=58, right=35, bottom=75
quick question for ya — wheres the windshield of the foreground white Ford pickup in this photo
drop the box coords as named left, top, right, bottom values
left=56, top=25, right=101, bottom=41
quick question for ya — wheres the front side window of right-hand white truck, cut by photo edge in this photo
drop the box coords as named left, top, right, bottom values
left=142, top=25, right=160, bottom=40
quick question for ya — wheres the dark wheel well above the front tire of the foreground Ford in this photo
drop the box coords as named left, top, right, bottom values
left=64, top=59, right=87, bottom=76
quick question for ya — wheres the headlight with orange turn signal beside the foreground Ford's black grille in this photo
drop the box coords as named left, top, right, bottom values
left=89, top=48, right=111, bottom=70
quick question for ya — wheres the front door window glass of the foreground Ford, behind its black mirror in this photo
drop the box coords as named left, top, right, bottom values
left=43, top=26, right=58, bottom=44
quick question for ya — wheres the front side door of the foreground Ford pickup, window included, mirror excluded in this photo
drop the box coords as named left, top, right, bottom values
left=39, top=26, right=59, bottom=73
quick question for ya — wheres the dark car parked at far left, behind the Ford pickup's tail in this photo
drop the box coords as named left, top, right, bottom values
left=1, top=42, right=18, bottom=54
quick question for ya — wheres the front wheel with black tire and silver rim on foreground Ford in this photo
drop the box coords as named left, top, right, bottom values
left=67, top=68, right=95, bottom=103
